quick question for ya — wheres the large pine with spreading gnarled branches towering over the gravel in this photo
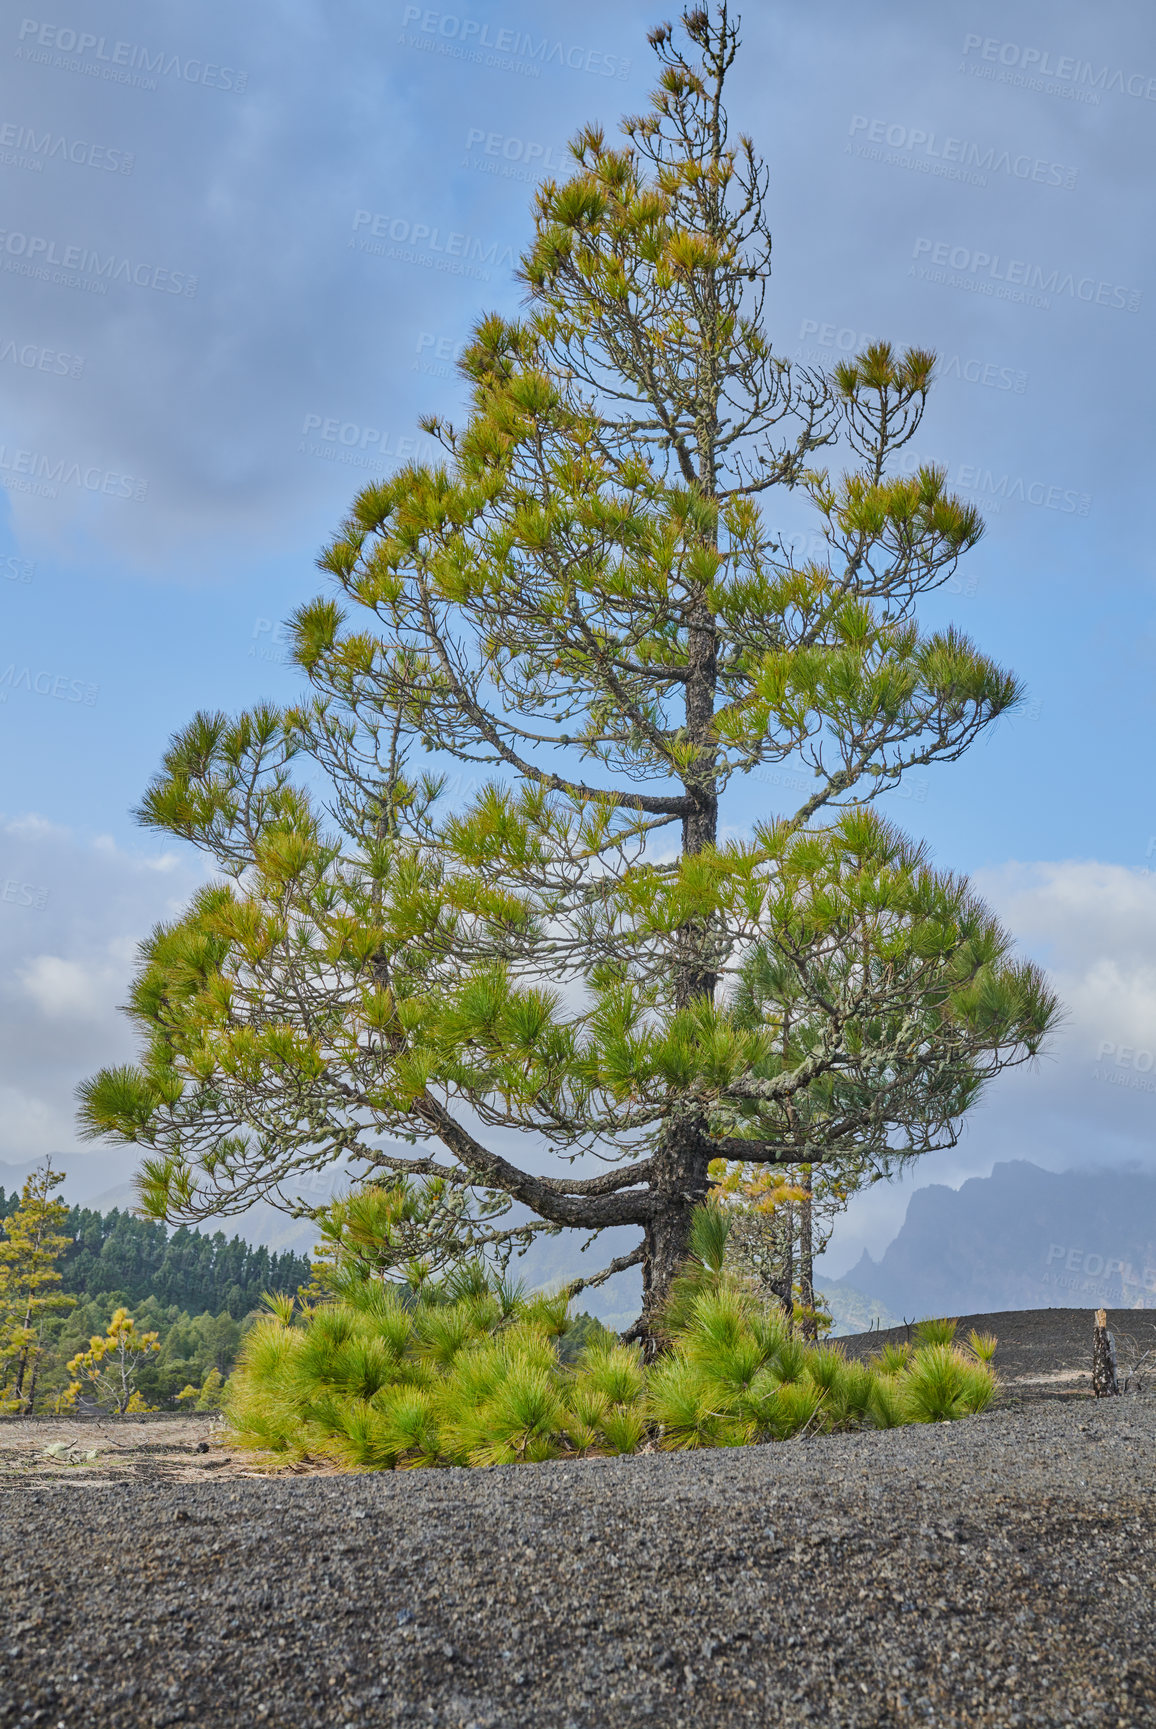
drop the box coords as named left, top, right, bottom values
left=81, top=7, right=1056, bottom=1338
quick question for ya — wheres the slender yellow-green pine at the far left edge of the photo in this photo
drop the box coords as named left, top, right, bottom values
left=0, top=1160, right=76, bottom=1414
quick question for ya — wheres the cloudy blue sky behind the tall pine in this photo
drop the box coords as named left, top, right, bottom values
left=0, top=0, right=1156, bottom=1264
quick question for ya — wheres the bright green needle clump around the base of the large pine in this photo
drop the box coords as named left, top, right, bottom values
left=226, top=1209, right=997, bottom=1471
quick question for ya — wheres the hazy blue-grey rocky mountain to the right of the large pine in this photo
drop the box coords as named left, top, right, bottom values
left=842, top=1158, right=1156, bottom=1319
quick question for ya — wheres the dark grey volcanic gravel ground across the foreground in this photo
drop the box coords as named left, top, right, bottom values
left=0, top=1390, right=1156, bottom=1729
